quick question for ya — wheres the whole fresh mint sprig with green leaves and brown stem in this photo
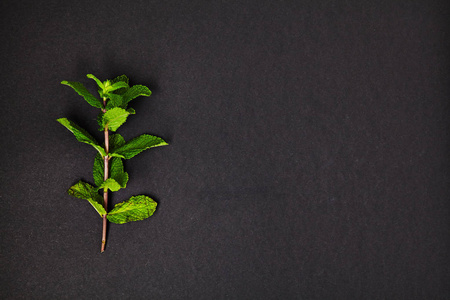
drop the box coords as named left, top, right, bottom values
left=57, top=74, right=167, bottom=252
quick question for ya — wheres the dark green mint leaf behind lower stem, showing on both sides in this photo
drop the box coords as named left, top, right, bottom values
left=92, top=154, right=128, bottom=188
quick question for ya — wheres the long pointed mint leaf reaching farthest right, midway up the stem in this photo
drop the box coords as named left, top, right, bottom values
left=109, top=134, right=168, bottom=159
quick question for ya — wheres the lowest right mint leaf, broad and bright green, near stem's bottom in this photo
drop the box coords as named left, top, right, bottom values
left=106, top=195, right=158, bottom=224
